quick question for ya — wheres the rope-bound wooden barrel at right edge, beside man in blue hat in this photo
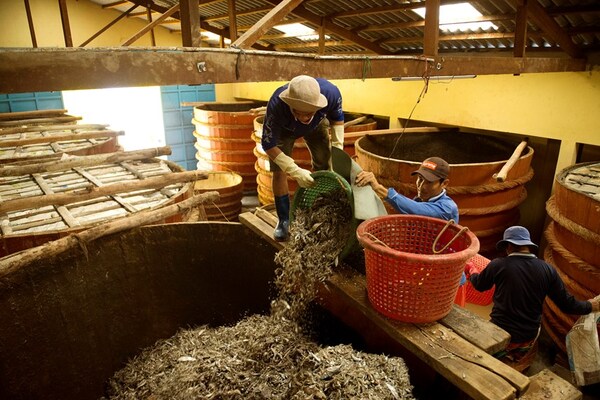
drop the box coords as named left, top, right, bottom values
left=542, top=162, right=600, bottom=356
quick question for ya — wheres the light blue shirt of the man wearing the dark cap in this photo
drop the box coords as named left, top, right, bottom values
left=385, top=188, right=458, bottom=224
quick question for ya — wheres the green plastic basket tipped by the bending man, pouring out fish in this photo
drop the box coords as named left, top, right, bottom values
left=290, top=171, right=360, bottom=260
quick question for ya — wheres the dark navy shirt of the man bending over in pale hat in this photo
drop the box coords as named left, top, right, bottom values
left=261, top=78, right=344, bottom=150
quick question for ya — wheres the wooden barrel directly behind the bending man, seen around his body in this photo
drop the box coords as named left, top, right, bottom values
left=252, top=113, right=377, bottom=205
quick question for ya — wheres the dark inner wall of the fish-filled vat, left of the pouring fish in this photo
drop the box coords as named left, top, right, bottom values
left=0, top=222, right=275, bottom=400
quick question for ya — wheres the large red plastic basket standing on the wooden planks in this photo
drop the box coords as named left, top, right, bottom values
left=356, top=214, right=479, bottom=323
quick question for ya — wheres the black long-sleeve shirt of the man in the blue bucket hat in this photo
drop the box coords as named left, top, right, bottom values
left=470, top=253, right=592, bottom=343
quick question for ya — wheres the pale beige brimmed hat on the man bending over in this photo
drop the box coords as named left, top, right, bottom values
left=279, top=75, right=327, bottom=112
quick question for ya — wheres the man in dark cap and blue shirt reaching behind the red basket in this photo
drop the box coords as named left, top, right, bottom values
left=355, top=157, right=458, bottom=223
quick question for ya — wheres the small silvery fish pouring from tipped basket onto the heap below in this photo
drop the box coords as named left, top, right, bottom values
left=107, top=188, right=414, bottom=400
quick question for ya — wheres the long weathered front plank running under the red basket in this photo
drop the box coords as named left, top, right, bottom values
left=320, top=271, right=529, bottom=400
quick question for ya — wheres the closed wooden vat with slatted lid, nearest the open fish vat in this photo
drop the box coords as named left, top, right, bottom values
left=0, top=158, right=193, bottom=256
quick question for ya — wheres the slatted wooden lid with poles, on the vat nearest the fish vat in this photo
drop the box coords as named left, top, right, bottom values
left=0, top=158, right=192, bottom=237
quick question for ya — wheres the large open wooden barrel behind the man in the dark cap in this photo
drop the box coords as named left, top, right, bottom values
left=355, top=131, right=533, bottom=258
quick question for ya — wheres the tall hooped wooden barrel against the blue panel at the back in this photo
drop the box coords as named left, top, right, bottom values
left=192, top=101, right=264, bottom=192
